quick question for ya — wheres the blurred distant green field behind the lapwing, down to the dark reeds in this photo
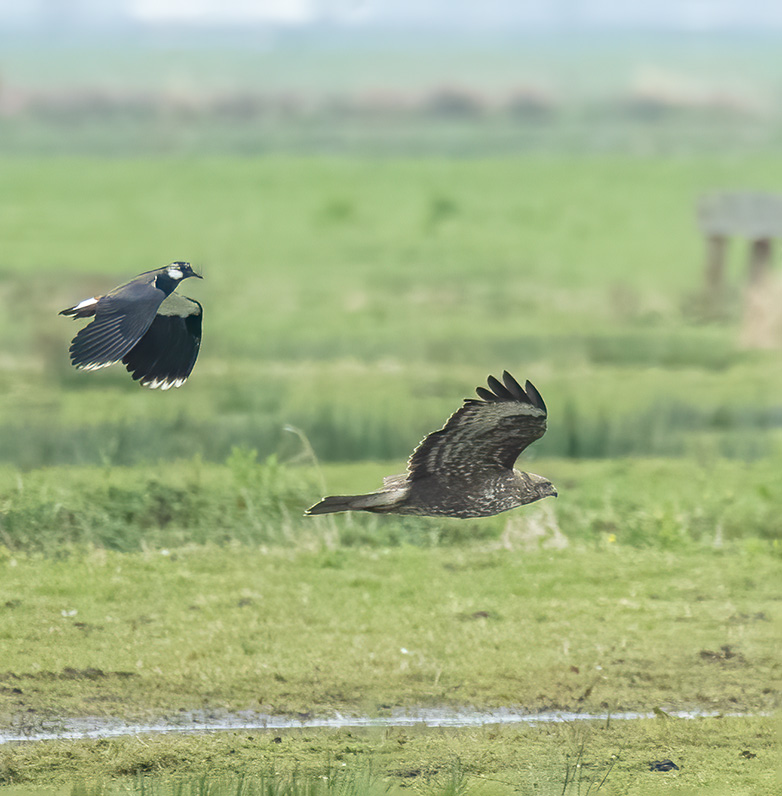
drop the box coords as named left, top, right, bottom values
left=0, top=157, right=782, bottom=468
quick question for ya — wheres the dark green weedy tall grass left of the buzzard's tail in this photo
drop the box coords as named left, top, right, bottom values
left=0, top=448, right=317, bottom=551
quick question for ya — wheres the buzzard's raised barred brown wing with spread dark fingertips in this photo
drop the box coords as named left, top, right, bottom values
left=408, top=371, right=546, bottom=481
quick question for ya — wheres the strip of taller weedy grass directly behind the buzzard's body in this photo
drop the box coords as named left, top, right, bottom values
left=0, top=454, right=782, bottom=555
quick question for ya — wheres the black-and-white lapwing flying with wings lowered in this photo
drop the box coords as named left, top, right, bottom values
left=60, top=262, right=203, bottom=390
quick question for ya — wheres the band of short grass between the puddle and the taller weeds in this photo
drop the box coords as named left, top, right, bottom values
left=0, top=542, right=779, bottom=726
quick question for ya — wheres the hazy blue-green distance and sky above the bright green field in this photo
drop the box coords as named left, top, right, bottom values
left=0, top=0, right=782, bottom=156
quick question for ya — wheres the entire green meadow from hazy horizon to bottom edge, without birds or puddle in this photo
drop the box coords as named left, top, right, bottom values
left=0, top=155, right=782, bottom=794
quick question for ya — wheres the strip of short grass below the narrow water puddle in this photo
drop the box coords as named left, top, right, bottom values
left=0, top=718, right=776, bottom=796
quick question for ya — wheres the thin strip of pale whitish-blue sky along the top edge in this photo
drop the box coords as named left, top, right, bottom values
left=0, top=0, right=782, bottom=31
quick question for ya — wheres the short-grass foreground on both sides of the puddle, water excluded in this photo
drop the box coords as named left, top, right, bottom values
left=0, top=544, right=779, bottom=793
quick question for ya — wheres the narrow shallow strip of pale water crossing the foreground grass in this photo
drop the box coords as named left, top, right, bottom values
left=0, top=708, right=745, bottom=744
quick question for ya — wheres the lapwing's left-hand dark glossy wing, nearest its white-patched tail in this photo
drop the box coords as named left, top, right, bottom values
left=65, top=277, right=166, bottom=370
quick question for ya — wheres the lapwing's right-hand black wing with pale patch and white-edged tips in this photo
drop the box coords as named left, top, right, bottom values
left=122, top=293, right=203, bottom=390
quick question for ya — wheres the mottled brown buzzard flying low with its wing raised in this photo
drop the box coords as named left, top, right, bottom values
left=307, top=371, right=557, bottom=518
